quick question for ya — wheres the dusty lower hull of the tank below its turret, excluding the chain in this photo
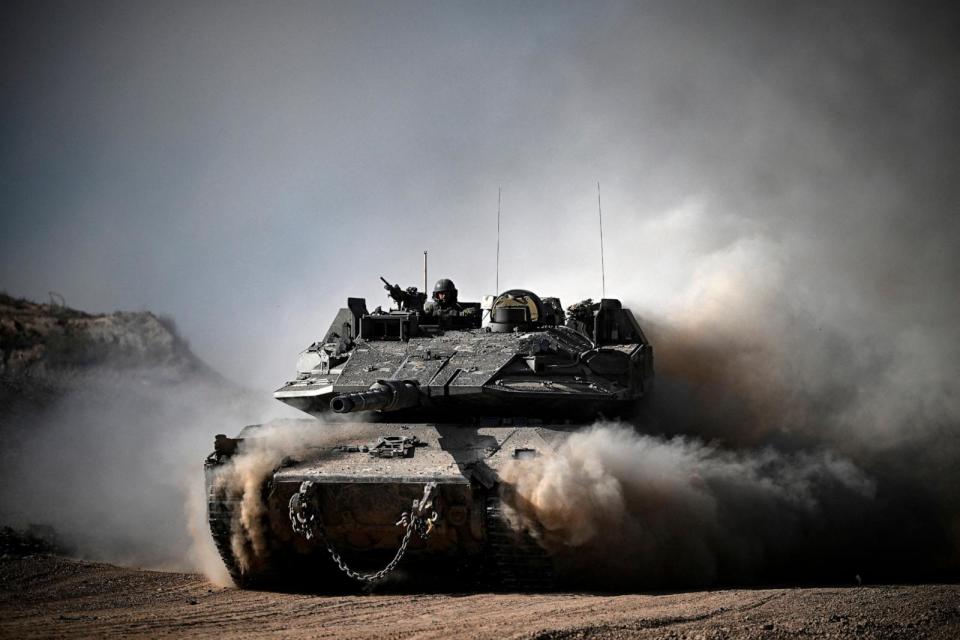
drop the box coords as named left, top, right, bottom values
left=206, top=421, right=578, bottom=589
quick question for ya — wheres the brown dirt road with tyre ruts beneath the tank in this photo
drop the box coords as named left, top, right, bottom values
left=0, top=556, right=960, bottom=639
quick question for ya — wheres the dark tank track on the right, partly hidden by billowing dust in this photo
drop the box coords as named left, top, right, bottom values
left=485, top=492, right=556, bottom=591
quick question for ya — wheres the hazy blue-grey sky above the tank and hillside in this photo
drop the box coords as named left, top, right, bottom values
left=0, top=1, right=960, bottom=389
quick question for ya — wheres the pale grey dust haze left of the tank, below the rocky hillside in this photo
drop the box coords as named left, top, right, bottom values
left=0, top=367, right=283, bottom=584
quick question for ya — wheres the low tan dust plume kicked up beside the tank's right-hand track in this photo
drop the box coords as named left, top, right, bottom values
left=502, top=424, right=875, bottom=587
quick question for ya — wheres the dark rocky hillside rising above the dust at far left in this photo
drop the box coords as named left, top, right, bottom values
left=0, top=294, right=210, bottom=378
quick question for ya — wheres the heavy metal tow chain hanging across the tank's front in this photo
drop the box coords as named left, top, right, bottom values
left=290, top=480, right=440, bottom=584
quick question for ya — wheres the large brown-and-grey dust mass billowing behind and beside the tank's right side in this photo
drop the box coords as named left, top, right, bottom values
left=502, top=232, right=960, bottom=587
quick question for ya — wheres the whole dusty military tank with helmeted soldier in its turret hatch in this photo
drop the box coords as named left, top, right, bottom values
left=205, top=277, right=653, bottom=590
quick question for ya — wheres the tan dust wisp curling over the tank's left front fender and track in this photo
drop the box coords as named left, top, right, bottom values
left=214, top=420, right=376, bottom=571
